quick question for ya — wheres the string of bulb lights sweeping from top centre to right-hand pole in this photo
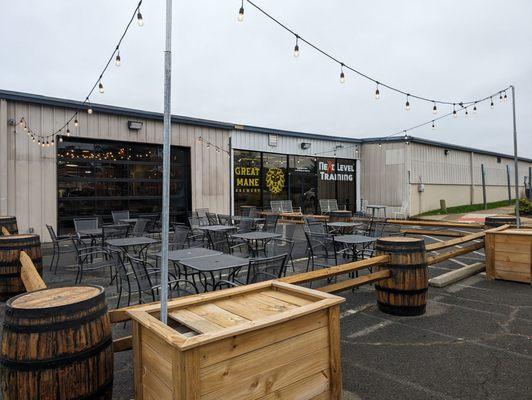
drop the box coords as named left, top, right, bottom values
left=237, top=0, right=510, bottom=155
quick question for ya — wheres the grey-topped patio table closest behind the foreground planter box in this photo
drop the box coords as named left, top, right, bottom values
left=179, top=254, right=249, bottom=291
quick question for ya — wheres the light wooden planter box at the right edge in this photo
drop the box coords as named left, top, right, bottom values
left=485, top=229, right=532, bottom=283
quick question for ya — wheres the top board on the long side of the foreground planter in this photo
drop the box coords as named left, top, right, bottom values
left=199, top=310, right=328, bottom=368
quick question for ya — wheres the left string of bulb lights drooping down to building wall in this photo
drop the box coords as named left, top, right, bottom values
left=15, top=0, right=144, bottom=147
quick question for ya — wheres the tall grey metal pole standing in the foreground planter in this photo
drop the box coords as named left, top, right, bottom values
left=161, top=0, right=172, bottom=324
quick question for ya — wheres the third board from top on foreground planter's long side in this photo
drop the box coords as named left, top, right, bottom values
left=201, top=347, right=329, bottom=400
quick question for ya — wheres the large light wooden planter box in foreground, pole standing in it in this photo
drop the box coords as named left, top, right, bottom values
left=129, top=281, right=344, bottom=400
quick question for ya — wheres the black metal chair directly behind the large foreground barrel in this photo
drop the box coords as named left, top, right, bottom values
left=70, top=235, right=114, bottom=284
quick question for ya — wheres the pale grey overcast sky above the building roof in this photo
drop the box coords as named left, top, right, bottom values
left=0, top=0, right=532, bottom=157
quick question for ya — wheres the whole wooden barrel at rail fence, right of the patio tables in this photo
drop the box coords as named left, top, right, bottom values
left=375, top=237, right=429, bottom=315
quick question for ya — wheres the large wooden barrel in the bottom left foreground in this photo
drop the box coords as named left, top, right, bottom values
left=0, top=286, right=113, bottom=400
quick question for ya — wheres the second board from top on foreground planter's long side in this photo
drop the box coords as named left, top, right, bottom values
left=201, top=327, right=329, bottom=398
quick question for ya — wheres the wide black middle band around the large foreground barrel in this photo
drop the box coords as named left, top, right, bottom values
left=0, top=336, right=113, bottom=371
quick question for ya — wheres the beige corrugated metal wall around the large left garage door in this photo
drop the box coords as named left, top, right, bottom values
left=0, top=100, right=229, bottom=240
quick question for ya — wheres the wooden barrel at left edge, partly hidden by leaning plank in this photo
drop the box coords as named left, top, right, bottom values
left=0, top=234, right=42, bottom=301
